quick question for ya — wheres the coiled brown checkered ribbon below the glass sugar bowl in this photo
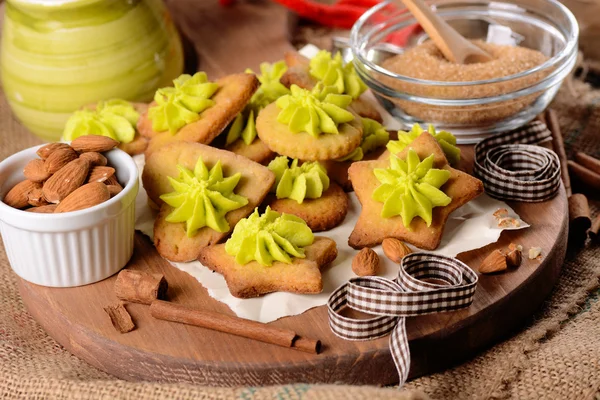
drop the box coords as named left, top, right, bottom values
left=473, top=121, right=560, bottom=202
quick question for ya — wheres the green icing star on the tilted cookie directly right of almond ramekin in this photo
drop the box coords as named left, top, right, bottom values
left=160, top=158, right=248, bottom=237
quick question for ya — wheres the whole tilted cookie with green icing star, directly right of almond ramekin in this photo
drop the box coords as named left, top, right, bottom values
left=142, top=142, right=275, bottom=261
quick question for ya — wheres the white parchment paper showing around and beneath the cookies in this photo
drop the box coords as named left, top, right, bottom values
left=134, top=45, right=529, bottom=322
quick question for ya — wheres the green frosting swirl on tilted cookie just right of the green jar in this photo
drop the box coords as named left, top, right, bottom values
left=148, top=72, right=219, bottom=134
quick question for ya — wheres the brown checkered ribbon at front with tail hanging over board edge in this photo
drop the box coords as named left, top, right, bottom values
left=327, top=253, right=477, bottom=385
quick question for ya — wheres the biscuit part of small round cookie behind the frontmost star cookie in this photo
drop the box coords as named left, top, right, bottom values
left=267, top=182, right=348, bottom=232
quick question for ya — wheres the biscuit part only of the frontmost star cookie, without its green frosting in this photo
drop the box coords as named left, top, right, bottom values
left=198, top=236, right=337, bottom=299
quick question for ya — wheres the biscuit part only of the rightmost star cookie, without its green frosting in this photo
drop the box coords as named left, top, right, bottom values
left=348, top=133, right=483, bottom=250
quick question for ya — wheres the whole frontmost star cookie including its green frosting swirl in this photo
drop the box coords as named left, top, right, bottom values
left=199, top=207, right=337, bottom=298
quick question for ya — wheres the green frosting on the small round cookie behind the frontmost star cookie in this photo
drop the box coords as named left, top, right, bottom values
left=268, top=156, right=329, bottom=204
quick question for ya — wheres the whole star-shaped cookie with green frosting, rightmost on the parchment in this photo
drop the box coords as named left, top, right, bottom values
left=348, top=132, right=483, bottom=250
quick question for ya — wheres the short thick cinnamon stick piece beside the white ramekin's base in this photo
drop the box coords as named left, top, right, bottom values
left=115, top=269, right=168, bottom=304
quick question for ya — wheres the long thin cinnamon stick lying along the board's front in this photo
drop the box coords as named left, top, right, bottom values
left=150, top=300, right=321, bottom=354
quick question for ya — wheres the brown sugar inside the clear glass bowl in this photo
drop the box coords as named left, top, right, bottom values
left=380, top=41, right=549, bottom=125
